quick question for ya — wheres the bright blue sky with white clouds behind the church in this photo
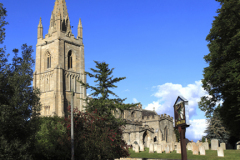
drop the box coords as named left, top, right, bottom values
left=1, top=0, right=221, bottom=141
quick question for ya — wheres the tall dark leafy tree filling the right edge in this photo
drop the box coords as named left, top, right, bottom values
left=199, top=0, right=240, bottom=138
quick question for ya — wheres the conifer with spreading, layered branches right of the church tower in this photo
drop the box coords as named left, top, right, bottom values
left=79, top=61, right=139, bottom=158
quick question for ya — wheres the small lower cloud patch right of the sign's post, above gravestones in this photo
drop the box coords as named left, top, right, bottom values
left=186, top=119, right=208, bottom=142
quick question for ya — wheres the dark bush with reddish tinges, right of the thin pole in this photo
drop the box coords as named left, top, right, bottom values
left=63, top=107, right=129, bottom=160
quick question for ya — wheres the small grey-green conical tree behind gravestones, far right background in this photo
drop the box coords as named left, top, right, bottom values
left=204, top=110, right=230, bottom=143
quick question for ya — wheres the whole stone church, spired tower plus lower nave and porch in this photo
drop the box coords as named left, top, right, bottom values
left=33, top=0, right=176, bottom=147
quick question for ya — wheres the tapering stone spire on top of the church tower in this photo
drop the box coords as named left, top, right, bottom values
left=48, top=0, right=72, bottom=34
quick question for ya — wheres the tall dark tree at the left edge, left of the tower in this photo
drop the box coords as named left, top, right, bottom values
left=0, top=3, right=40, bottom=160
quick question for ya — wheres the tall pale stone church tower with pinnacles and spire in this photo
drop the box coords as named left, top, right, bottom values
left=33, top=0, right=86, bottom=117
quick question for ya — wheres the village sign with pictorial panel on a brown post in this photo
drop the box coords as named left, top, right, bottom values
left=173, top=96, right=189, bottom=160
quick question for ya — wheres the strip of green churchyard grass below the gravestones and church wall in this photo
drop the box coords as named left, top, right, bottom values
left=126, top=148, right=240, bottom=160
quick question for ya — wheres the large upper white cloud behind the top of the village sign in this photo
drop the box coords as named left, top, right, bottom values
left=145, top=81, right=207, bottom=119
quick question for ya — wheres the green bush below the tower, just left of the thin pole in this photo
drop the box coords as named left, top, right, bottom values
left=34, top=116, right=68, bottom=160
